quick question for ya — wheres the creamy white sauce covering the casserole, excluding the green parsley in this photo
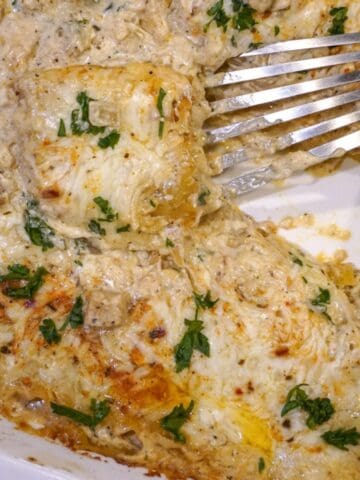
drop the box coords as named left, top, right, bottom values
left=0, top=0, right=360, bottom=480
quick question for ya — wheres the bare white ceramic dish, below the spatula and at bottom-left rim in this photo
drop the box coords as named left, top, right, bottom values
left=0, top=161, right=360, bottom=480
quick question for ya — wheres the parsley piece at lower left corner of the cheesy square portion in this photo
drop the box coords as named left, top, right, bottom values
left=24, top=200, right=55, bottom=251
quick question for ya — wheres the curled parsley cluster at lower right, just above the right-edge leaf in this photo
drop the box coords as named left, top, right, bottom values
left=281, top=383, right=335, bottom=429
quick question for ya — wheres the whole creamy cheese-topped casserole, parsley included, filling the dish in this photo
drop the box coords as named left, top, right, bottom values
left=0, top=0, right=360, bottom=480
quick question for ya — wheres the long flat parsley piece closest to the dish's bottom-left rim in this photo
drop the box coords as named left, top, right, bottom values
left=50, top=398, right=110, bottom=428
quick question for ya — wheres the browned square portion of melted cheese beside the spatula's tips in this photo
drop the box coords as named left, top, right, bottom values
left=17, top=64, right=218, bottom=236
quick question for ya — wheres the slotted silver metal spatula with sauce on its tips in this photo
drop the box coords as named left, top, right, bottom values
left=205, top=33, right=360, bottom=195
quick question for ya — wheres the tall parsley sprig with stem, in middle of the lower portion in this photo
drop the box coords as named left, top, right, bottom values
left=175, top=291, right=218, bottom=372
